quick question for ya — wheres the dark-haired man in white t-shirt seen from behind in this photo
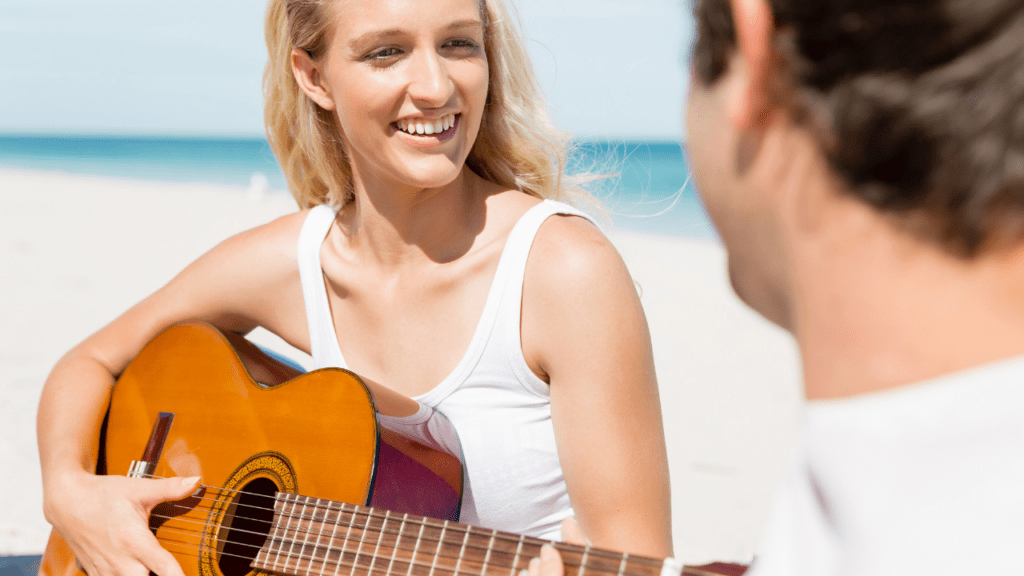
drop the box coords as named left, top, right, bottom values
left=531, top=0, right=1024, bottom=576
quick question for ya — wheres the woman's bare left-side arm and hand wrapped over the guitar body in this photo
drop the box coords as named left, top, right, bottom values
left=37, top=214, right=305, bottom=576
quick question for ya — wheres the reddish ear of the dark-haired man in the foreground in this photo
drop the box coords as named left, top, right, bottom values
left=727, top=0, right=774, bottom=129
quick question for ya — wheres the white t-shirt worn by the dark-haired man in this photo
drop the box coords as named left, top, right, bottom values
left=749, top=358, right=1024, bottom=576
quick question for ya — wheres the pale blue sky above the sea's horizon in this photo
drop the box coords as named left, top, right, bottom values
left=0, top=0, right=692, bottom=139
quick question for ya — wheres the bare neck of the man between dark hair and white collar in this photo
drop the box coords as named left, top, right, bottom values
left=793, top=212, right=1024, bottom=400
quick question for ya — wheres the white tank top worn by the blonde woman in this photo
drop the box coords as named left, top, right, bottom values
left=298, top=200, right=593, bottom=539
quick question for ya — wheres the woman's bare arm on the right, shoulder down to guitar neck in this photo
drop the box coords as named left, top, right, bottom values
left=522, top=213, right=672, bottom=557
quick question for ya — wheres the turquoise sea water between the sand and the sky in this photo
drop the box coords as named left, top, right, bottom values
left=0, top=136, right=714, bottom=238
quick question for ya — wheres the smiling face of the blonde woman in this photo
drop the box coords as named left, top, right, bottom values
left=294, top=0, right=488, bottom=188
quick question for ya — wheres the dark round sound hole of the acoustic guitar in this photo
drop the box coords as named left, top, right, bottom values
left=217, top=478, right=278, bottom=576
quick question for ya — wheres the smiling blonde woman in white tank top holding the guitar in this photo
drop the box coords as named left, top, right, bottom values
left=38, top=0, right=672, bottom=576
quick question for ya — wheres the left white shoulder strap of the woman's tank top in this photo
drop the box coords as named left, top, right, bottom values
left=297, top=204, right=345, bottom=368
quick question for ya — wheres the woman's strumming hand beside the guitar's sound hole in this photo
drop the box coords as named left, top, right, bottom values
left=44, top=474, right=200, bottom=576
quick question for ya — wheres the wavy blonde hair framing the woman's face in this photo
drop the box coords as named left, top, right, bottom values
left=263, top=0, right=593, bottom=208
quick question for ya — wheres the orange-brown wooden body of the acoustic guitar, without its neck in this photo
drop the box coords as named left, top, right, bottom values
left=40, top=323, right=462, bottom=576
